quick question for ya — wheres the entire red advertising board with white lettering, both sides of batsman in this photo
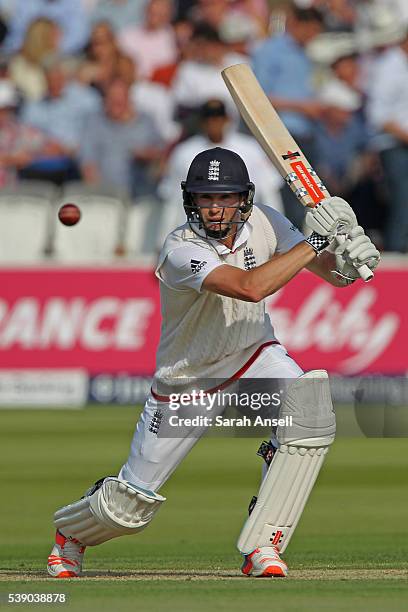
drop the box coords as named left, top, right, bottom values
left=0, top=267, right=408, bottom=376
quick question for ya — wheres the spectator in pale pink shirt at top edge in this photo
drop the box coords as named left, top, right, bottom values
left=119, top=0, right=177, bottom=78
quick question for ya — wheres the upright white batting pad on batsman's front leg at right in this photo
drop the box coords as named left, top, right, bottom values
left=237, top=370, right=336, bottom=554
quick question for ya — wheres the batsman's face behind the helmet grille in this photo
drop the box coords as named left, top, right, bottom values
left=194, top=193, right=242, bottom=237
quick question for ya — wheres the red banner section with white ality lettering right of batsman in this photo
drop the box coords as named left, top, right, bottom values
left=268, top=268, right=402, bottom=375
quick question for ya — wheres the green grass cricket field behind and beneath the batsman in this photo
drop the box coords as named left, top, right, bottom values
left=0, top=407, right=408, bottom=612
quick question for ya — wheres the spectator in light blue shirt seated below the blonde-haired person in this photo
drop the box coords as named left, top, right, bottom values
left=22, top=60, right=102, bottom=166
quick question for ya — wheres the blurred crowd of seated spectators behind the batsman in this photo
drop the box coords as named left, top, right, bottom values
left=0, top=0, right=408, bottom=253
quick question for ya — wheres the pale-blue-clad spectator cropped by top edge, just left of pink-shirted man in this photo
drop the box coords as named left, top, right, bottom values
left=89, top=0, right=147, bottom=33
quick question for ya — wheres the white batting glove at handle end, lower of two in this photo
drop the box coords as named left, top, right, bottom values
left=331, top=225, right=380, bottom=281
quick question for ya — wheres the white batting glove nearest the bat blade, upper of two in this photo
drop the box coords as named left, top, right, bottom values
left=305, top=197, right=357, bottom=241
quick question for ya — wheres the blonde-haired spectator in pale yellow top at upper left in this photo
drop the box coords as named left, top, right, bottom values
left=9, top=17, right=61, bottom=100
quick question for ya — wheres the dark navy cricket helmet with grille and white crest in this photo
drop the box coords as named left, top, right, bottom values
left=181, top=147, right=255, bottom=240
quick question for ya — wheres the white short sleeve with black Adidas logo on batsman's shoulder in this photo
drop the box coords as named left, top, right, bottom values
left=158, top=246, right=224, bottom=293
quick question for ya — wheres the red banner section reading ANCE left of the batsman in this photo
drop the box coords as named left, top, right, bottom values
left=0, top=268, right=160, bottom=375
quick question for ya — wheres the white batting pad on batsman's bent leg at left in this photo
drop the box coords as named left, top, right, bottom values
left=54, top=476, right=166, bottom=546
